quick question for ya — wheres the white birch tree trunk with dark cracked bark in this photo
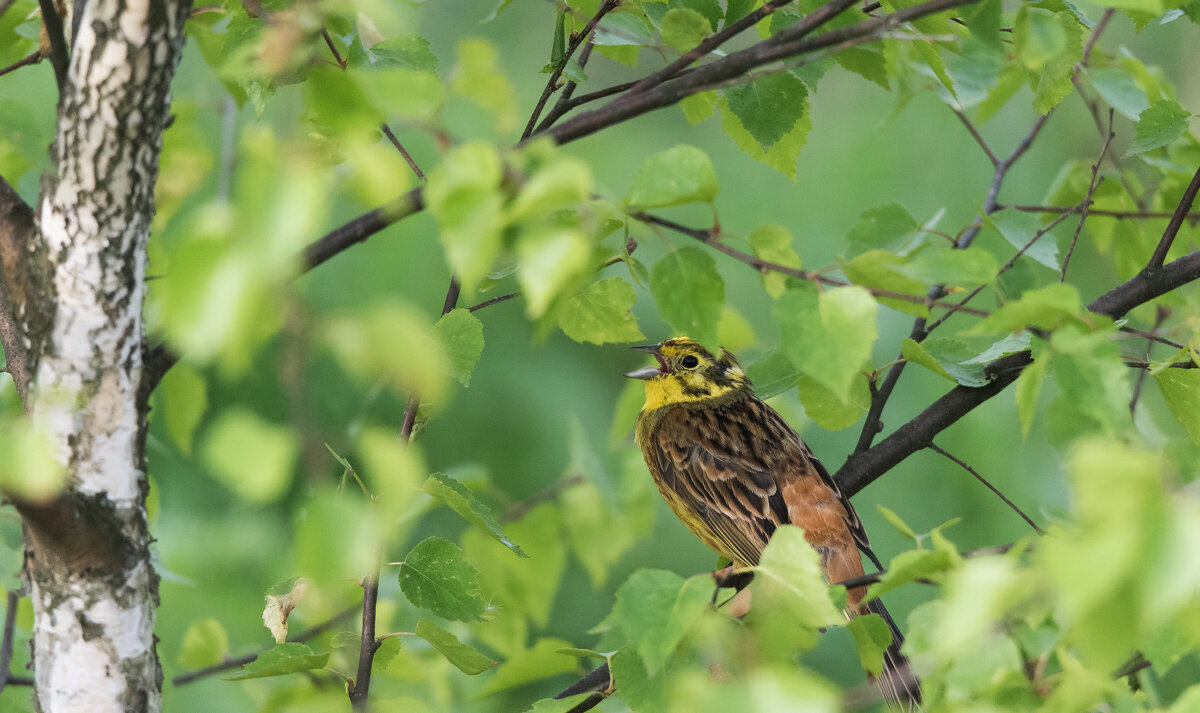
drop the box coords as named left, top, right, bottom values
left=0, top=0, right=191, bottom=713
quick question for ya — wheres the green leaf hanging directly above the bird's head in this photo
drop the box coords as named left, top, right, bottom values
left=650, top=247, right=725, bottom=348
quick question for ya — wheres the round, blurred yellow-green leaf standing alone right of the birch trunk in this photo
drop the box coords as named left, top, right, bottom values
left=202, top=406, right=299, bottom=503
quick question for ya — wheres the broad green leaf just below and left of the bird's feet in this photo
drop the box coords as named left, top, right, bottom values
left=606, top=569, right=713, bottom=675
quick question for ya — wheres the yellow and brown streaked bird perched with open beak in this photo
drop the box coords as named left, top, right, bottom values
left=625, top=336, right=920, bottom=711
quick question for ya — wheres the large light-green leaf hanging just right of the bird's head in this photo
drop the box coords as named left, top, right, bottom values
left=772, top=286, right=878, bottom=402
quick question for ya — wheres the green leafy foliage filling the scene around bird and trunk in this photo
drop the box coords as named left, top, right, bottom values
left=0, top=0, right=1200, bottom=713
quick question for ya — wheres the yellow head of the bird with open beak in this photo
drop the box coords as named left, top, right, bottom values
left=625, top=337, right=750, bottom=411
